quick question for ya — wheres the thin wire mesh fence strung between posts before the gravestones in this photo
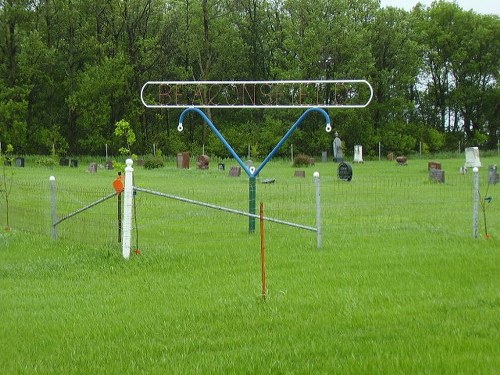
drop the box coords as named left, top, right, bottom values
left=0, top=164, right=500, bottom=247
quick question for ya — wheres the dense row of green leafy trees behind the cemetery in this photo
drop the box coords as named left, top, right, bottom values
left=0, top=0, right=500, bottom=156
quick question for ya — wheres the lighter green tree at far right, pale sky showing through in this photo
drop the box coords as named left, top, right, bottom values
left=414, top=1, right=500, bottom=145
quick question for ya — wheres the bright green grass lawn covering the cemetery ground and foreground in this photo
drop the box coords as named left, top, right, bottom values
left=0, top=157, right=500, bottom=374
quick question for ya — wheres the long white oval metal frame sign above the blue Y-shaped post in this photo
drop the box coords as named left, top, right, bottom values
left=141, top=80, right=373, bottom=108
